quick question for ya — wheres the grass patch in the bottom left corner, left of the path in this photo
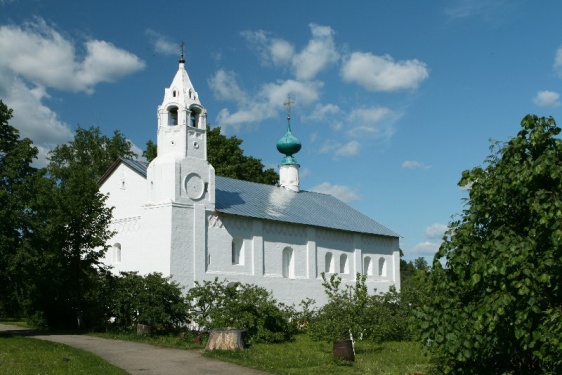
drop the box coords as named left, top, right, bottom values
left=0, top=335, right=127, bottom=375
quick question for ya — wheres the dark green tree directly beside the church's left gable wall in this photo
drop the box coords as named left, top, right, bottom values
left=23, top=127, right=134, bottom=327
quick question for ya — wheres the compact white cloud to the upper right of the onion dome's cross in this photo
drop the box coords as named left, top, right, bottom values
left=341, top=52, right=429, bottom=91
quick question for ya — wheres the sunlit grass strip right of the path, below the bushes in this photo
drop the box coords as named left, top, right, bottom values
left=205, top=335, right=429, bottom=375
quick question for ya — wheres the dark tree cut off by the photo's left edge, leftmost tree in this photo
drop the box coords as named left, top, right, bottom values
left=0, top=100, right=37, bottom=316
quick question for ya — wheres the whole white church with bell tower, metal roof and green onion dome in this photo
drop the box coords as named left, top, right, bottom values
left=100, top=54, right=400, bottom=305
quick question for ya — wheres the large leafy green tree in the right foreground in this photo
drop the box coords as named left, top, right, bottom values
left=417, top=115, right=562, bottom=374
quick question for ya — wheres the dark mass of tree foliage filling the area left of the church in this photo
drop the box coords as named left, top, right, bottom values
left=0, top=113, right=134, bottom=328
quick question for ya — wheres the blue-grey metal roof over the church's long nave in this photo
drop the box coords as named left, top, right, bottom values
left=215, top=176, right=398, bottom=237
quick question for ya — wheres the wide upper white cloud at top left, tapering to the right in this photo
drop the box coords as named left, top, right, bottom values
left=0, top=18, right=144, bottom=93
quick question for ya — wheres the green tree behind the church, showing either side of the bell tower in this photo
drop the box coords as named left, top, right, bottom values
left=143, top=126, right=279, bottom=185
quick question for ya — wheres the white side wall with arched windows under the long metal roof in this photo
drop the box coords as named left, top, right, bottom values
left=197, top=212, right=399, bottom=305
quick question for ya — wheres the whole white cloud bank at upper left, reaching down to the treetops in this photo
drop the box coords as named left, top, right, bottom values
left=0, top=18, right=144, bottom=166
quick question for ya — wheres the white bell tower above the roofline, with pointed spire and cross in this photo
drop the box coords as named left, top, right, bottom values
left=147, top=42, right=215, bottom=209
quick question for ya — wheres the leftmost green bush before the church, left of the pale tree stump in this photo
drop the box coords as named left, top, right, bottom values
left=109, top=272, right=187, bottom=329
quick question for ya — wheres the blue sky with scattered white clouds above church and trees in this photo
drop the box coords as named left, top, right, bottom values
left=0, top=0, right=562, bottom=261
